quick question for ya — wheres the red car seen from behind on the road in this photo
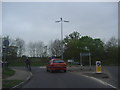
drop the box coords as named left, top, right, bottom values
left=47, top=59, right=67, bottom=72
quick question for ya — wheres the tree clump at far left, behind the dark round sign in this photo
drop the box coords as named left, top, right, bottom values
left=2, top=36, right=25, bottom=58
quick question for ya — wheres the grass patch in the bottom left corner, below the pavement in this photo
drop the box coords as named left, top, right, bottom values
left=2, top=80, right=23, bottom=88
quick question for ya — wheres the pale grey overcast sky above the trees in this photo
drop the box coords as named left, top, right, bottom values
left=2, top=2, right=118, bottom=44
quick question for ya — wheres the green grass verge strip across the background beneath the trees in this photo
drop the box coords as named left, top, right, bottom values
left=6, top=57, right=120, bottom=66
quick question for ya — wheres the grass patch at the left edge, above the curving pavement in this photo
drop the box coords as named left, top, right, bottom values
left=2, top=68, right=15, bottom=79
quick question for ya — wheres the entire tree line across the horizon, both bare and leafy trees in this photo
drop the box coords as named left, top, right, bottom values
left=0, top=32, right=118, bottom=64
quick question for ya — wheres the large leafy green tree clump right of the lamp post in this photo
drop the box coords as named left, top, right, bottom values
left=64, top=32, right=104, bottom=59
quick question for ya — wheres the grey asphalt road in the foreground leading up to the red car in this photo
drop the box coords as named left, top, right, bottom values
left=22, top=67, right=111, bottom=88
